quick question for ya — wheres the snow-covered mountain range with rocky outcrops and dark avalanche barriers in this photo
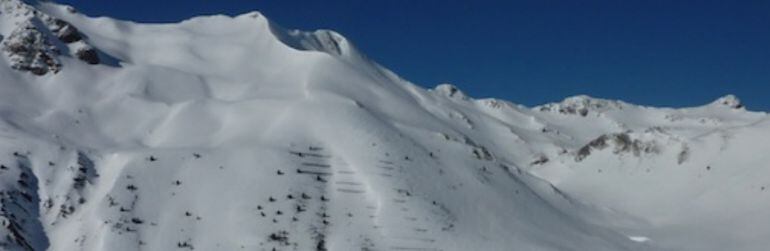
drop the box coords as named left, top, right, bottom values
left=0, top=0, right=770, bottom=250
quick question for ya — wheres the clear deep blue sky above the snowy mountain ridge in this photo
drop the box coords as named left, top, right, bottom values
left=54, top=0, right=770, bottom=111
